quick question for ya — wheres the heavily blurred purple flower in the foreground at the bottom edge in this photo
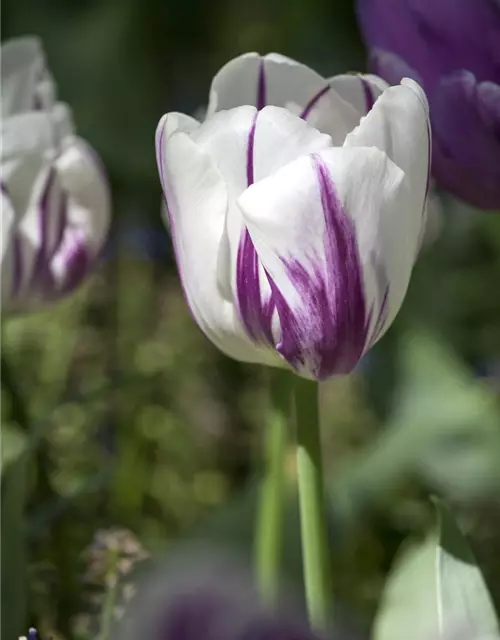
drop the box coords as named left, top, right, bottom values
left=114, top=553, right=358, bottom=640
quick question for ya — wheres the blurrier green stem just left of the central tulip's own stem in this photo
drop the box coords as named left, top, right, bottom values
left=255, top=370, right=292, bottom=605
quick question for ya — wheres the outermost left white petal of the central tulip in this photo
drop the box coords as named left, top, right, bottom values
left=157, top=117, right=272, bottom=362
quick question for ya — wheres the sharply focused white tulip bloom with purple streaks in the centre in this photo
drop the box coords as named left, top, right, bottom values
left=156, top=53, right=430, bottom=380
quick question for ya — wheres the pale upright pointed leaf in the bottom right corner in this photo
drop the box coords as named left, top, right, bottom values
left=373, top=500, right=499, bottom=640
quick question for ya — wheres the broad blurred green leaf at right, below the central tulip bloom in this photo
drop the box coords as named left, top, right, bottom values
left=330, top=330, right=500, bottom=512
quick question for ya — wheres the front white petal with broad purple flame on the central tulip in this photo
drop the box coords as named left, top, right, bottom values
left=239, top=148, right=411, bottom=379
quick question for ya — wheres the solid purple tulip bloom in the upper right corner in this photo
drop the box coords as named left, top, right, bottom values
left=358, top=0, right=500, bottom=209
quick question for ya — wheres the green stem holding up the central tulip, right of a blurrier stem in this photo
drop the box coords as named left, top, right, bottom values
left=295, top=378, right=332, bottom=629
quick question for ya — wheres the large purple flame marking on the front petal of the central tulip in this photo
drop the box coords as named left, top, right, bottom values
left=270, top=155, right=370, bottom=380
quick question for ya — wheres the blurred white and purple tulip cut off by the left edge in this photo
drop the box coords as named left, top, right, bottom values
left=0, top=37, right=111, bottom=314
